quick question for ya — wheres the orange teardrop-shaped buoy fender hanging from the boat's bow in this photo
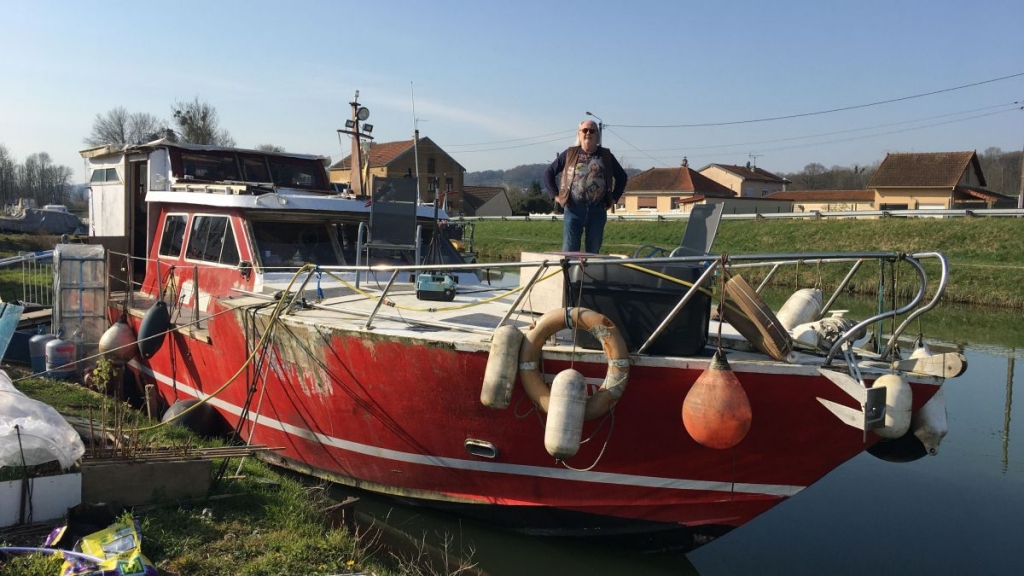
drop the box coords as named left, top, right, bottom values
left=683, top=351, right=754, bottom=449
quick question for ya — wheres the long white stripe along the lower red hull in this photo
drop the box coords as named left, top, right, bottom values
left=131, top=360, right=806, bottom=497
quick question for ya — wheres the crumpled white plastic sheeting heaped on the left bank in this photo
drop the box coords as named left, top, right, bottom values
left=0, top=370, right=85, bottom=469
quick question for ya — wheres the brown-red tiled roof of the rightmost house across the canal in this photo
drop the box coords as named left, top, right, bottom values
left=867, top=152, right=985, bottom=189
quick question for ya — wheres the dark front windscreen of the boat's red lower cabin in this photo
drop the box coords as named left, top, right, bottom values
left=252, top=220, right=344, bottom=268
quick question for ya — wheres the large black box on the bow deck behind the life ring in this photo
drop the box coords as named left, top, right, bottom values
left=566, top=264, right=711, bottom=356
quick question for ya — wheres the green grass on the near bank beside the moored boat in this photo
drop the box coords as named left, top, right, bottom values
left=0, top=367, right=452, bottom=576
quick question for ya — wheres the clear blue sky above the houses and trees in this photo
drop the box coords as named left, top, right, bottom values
left=0, top=0, right=1024, bottom=180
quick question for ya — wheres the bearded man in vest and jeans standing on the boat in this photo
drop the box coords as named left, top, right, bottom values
left=544, top=120, right=627, bottom=254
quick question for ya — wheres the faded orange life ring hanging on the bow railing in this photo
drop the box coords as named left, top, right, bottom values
left=519, top=307, right=630, bottom=420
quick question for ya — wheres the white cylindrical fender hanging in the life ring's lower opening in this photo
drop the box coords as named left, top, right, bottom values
left=544, top=368, right=587, bottom=460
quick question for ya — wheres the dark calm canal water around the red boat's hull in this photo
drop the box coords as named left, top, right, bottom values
left=331, top=306, right=1024, bottom=576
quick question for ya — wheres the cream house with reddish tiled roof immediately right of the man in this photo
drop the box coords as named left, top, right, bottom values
left=616, top=160, right=735, bottom=214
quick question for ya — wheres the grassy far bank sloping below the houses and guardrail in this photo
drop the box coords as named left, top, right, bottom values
left=474, top=218, right=1024, bottom=308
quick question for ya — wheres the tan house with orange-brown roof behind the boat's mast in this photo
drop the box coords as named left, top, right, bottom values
left=328, top=136, right=466, bottom=212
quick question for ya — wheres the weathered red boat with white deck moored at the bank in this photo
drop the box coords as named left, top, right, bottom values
left=91, top=141, right=963, bottom=547
